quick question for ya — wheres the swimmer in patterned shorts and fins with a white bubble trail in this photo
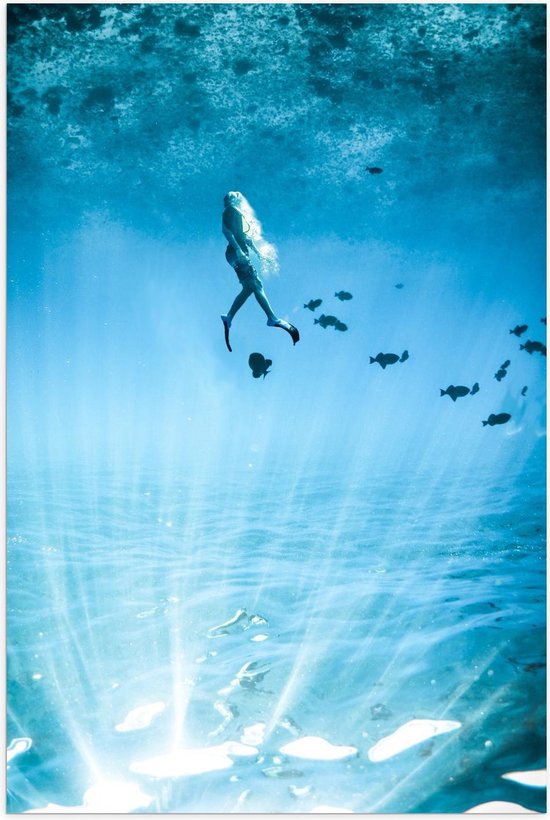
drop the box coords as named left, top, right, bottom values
left=222, top=191, right=300, bottom=352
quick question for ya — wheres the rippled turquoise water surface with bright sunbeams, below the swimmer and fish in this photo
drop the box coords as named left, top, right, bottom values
left=8, top=451, right=545, bottom=812
